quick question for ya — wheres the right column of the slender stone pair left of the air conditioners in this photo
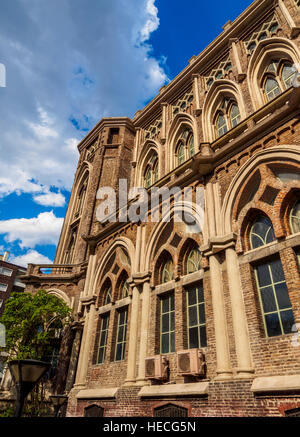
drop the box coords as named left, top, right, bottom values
left=136, top=275, right=150, bottom=385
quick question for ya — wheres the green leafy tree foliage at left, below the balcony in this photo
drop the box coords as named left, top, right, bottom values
left=0, top=290, right=71, bottom=360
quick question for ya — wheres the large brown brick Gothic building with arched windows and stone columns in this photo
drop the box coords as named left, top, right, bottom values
left=23, top=0, right=300, bottom=416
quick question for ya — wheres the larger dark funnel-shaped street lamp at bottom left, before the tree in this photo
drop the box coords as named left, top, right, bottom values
left=8, top=360, right=51, bottom=417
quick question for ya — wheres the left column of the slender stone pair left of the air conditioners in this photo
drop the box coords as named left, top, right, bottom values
left=124, top=282, right=140, bottom=385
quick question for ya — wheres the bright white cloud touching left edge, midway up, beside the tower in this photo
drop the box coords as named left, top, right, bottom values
left=0, top=211, right=63, bottom=249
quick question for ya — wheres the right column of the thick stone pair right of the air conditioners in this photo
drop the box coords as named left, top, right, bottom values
left=226, top=246, right=254, bottom=378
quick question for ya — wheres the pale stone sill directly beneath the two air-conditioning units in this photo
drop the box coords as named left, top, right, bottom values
left=138, top=382, right=209, bottom=398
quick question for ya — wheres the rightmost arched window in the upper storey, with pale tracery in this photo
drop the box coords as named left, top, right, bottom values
left=262, top=59, right=295, bottom=102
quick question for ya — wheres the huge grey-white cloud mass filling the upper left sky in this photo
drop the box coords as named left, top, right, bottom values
left=0, top=0, right=167, bottom=198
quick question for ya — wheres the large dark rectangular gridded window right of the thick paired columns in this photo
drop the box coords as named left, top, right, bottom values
left=255, top=258, right=294, bottom=337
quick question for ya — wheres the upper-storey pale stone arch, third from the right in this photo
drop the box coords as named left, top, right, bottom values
left=165, top=112, right=199, bottom=173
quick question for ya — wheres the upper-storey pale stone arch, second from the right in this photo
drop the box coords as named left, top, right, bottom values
left=202, top=79, right=247, bottom=143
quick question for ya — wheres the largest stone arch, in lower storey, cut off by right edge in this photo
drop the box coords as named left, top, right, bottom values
left=221, top=145, right=300, bottom=235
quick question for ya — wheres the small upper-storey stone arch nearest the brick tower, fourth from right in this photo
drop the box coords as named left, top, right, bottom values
left=136, top=140, right=163, bottom=187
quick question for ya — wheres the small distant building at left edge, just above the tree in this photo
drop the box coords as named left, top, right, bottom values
left=0, top=252, right=26, bottom=317
